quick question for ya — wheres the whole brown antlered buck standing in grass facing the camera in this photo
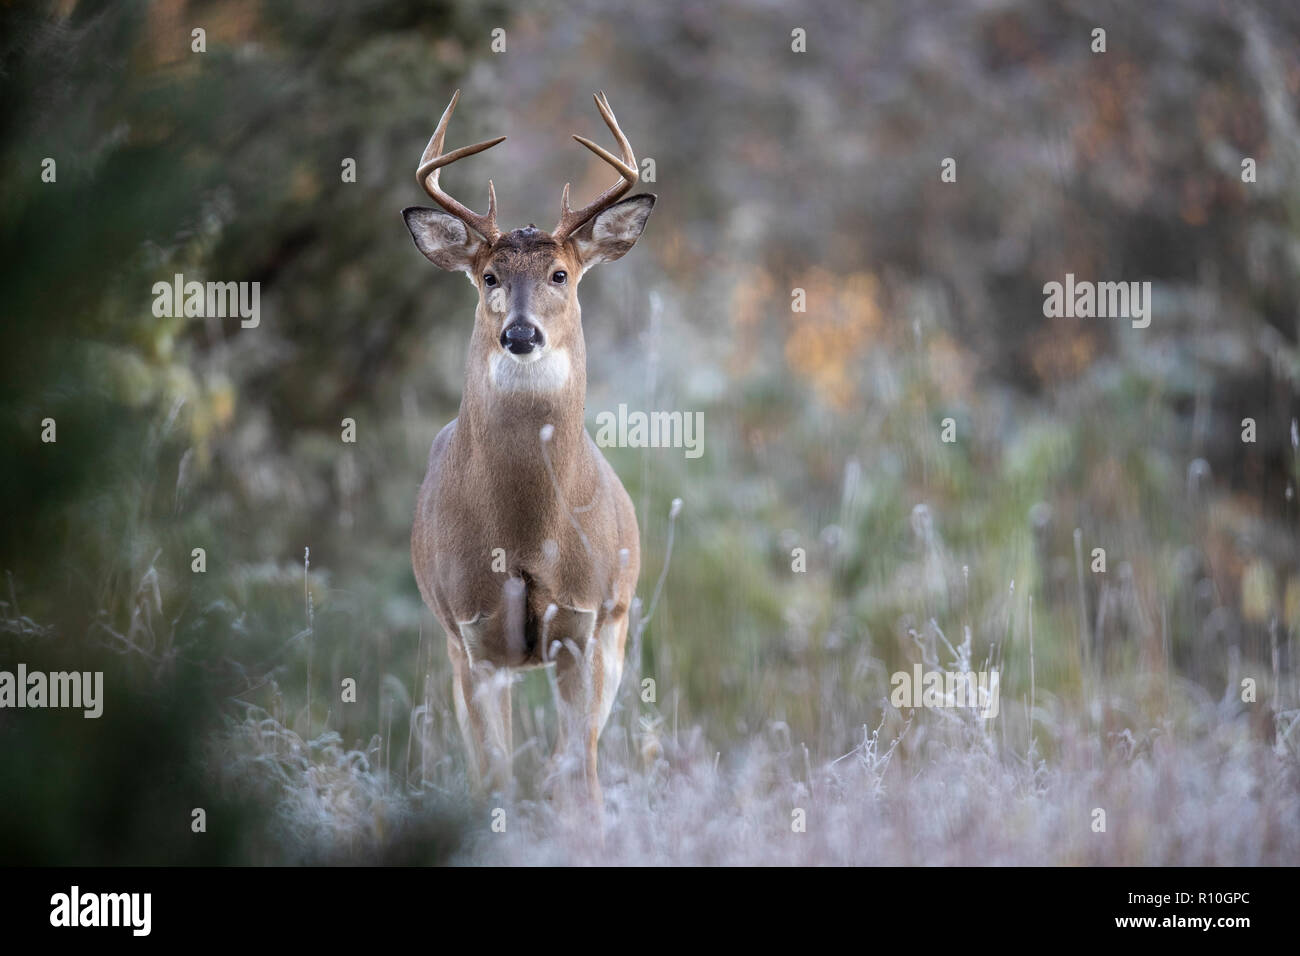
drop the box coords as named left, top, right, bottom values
left=402, top=90, right=655, bottom=805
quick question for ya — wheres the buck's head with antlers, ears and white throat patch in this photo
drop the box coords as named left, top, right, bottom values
left=402, top=90, right=655, bottom=390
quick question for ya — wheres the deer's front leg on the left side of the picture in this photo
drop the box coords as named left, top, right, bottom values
left=447, top=635, right=514, bottom=793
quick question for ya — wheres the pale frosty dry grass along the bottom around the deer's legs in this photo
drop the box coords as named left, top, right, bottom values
left=213, top=621, right=1300, bottom=866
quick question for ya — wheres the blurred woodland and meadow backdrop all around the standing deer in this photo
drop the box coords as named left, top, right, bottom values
left=0, top=0, right=1300, bottom=864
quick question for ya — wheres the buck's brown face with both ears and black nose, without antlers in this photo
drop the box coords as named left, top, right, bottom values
left=402, top=195, right=655, bottom=371
